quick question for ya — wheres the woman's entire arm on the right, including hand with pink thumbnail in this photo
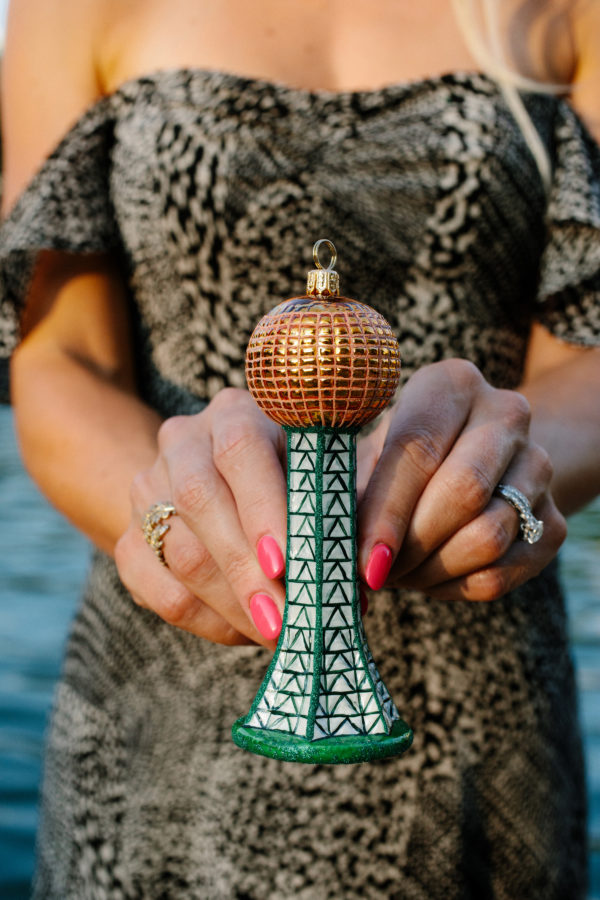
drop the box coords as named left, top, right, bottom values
left=360, top=7, right=600, bottom=600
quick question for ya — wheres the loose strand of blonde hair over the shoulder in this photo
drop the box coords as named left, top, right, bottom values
left=452, top=0, right=568, bottom=191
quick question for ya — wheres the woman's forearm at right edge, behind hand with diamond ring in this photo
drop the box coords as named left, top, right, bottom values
left=519, top=350, right=600, bottom=515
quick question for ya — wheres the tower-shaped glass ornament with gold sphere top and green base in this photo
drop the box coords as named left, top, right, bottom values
left=232, top=240, right=413, bottom=763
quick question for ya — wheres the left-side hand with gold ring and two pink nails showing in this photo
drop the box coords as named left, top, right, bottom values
left=115, top=388, right=286, bottom=649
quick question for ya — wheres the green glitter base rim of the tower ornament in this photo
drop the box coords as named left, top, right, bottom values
left=231, top=716, right=413, bottom=763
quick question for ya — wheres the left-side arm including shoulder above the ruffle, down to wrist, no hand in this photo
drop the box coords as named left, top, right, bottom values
left=2, top=0, right=159, bottom=551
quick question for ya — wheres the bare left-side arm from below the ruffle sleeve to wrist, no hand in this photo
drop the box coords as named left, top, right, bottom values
left=11, top=253, right=161, bottom=554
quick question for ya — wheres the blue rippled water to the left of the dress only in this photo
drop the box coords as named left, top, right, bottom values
left=0, top=407, right=89, bottom=900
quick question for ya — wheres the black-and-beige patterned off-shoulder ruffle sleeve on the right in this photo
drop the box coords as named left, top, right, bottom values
left=536, top=102, right=600, bottom=346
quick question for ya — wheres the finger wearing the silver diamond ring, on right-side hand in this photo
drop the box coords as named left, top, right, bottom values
left=390, top=445, right=552, bottom=590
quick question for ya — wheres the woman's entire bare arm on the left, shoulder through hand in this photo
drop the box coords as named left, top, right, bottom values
left=3, top=0, right=285, bottom=646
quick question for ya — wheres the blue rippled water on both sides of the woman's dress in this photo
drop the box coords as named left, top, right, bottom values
left=0, top=407, right=600, bottom=900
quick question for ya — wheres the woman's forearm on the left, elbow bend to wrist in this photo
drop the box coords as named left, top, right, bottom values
left=11, top=340, right=162, bottom=554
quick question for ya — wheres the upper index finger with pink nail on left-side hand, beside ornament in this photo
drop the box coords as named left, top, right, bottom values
left=212, top=403, right=287, bottom=578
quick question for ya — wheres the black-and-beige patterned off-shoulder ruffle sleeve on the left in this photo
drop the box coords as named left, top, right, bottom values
left=0, top=98, right=119, bottom=402
